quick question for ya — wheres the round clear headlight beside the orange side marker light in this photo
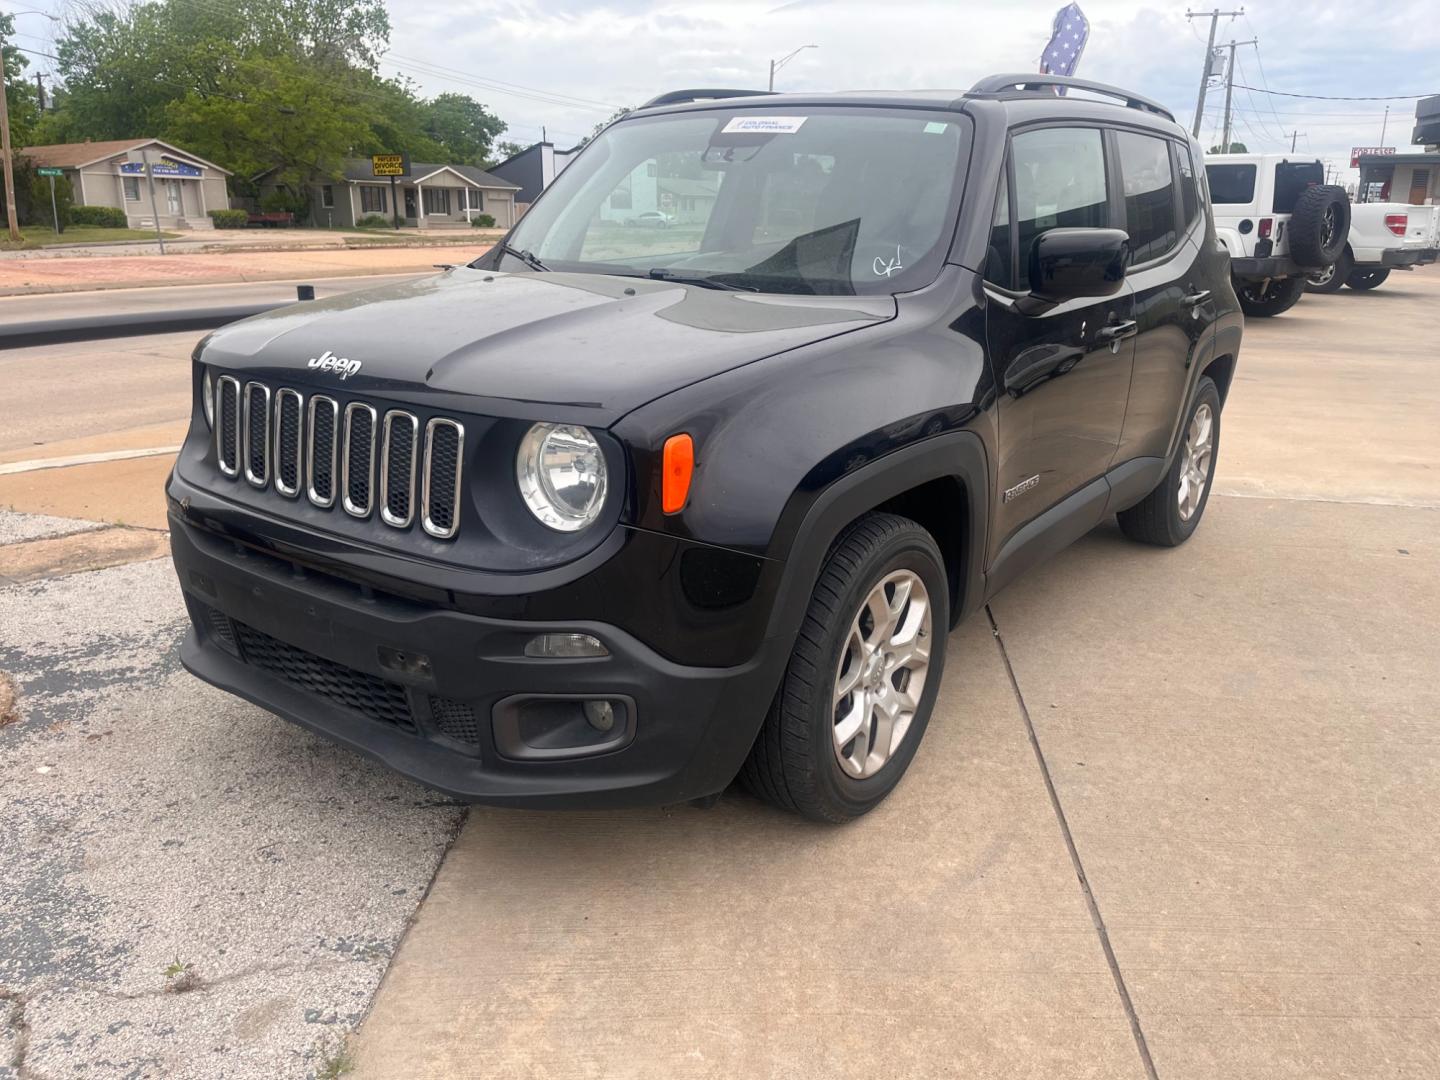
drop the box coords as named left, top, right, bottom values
left=516, top=423, right=605, bottom=533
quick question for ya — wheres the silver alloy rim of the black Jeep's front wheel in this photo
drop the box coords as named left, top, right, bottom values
left=832, top=570, right=932, bottom=779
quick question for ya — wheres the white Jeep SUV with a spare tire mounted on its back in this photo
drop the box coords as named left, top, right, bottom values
left=1205, top=154, right=1351, bottom=317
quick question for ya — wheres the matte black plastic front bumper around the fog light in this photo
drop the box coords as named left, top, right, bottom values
left=170, top=514, right=788, bottom=808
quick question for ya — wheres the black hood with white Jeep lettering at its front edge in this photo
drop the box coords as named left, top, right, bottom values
left=203, top=268, right=896, bottom=426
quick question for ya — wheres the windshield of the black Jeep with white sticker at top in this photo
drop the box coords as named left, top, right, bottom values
left=503, top=108, right=969, bottom=295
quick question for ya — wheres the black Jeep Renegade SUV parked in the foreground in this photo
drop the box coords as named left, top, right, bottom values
left=168, top=75, right=1241, bottom=821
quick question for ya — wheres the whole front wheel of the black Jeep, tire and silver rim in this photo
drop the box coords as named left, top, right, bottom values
left=740, top=513, right=950, bottom=824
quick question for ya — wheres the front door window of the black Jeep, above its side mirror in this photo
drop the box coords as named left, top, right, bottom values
left=1011, top=128, right=1110, bottom=289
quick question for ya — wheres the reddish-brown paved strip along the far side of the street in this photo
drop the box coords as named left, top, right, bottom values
left=0, top=244, right=491, bottom=297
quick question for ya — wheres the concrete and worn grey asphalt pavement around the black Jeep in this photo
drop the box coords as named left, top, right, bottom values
left=0, top=269, right=1440, bottom=1080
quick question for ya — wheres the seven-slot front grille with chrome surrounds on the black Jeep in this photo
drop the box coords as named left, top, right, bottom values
left=215, top=374, right=465, bottom=540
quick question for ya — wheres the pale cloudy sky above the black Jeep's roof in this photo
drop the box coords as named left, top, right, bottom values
left=384, top=0, right=1440, bottom=184
